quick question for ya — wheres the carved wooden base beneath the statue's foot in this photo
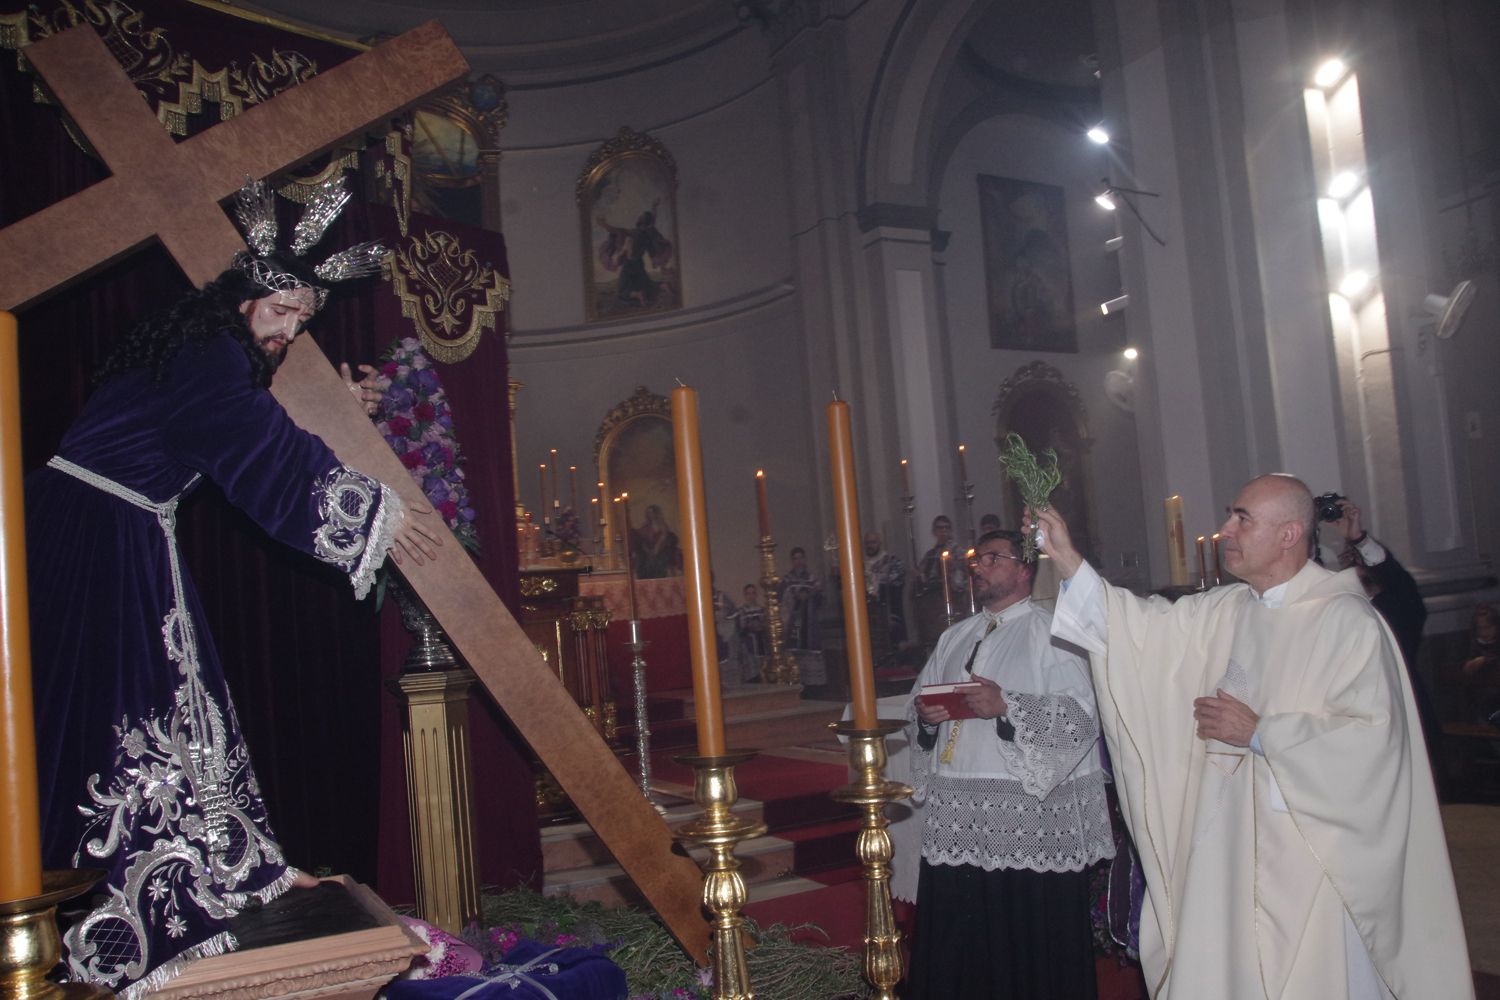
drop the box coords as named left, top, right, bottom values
left=147, top=876, right=428, bottom=1000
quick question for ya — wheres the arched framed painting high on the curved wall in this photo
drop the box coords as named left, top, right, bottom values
left=576, top=127, right=683, bottom=322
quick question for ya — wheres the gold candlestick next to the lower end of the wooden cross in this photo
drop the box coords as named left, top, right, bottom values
left=674, top=750, right=768, bottom=1000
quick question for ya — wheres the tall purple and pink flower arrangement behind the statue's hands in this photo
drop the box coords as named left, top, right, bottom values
left=375, top=337, right=479, bottom=552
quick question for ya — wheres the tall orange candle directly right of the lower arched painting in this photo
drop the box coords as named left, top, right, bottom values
left=672, top=385, right=725, bottom=757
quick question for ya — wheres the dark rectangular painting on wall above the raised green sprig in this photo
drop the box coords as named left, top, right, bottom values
left=980, top=174, right=1079, bottom=352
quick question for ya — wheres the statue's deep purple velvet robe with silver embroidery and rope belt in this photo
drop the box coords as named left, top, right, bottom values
left=26, top=333, right=401, bottom=997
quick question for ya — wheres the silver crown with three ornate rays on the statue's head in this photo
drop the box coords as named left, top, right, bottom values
left=230, top=174, right=387, bottom=309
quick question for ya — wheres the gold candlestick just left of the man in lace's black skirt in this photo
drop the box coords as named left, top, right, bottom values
left=828, top=718, right=912, bottom=1000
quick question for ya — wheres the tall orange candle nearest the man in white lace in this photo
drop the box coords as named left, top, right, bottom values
left=828, top=399, right=876, bottom=729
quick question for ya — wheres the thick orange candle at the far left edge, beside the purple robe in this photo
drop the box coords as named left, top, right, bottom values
left=0, top=312, right=42, bottom=903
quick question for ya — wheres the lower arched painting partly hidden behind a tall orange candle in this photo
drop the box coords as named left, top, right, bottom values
left=594, top=385, right=683, bottom=580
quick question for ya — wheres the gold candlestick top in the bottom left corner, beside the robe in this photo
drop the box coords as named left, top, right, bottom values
left=0, top=868, right=114, bottom=1000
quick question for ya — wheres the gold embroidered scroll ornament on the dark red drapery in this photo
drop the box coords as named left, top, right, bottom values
left=390, top=229, right=510, bottom=364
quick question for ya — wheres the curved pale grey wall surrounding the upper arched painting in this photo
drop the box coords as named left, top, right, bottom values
left=501, top=41, right=819, bottom=594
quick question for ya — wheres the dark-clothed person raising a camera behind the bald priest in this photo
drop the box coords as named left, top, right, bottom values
left=1316, top=493, right=1443, bottom=754
